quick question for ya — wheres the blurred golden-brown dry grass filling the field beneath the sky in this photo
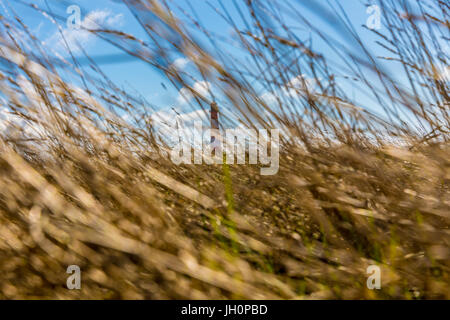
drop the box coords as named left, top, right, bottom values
left=0, top=0, right=450, bottom=299
